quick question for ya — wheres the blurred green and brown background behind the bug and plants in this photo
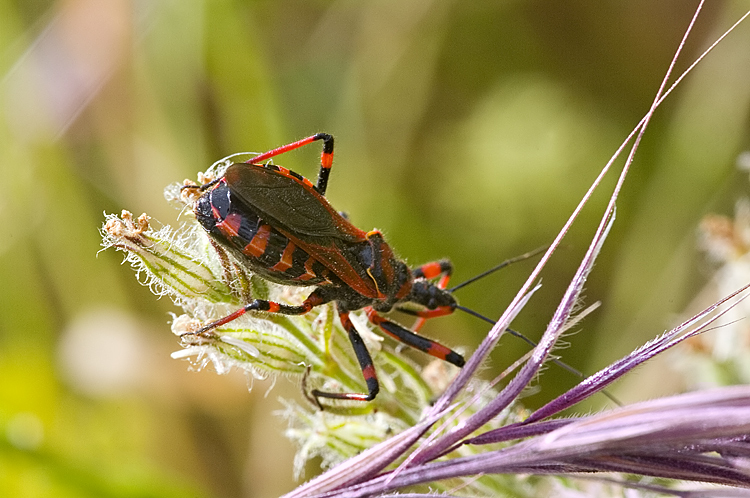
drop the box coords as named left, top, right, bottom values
left=0, top=0, right=750, bottom=497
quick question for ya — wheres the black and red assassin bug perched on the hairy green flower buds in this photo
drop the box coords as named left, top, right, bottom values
left=183, top=133, right=464, bottom=404
